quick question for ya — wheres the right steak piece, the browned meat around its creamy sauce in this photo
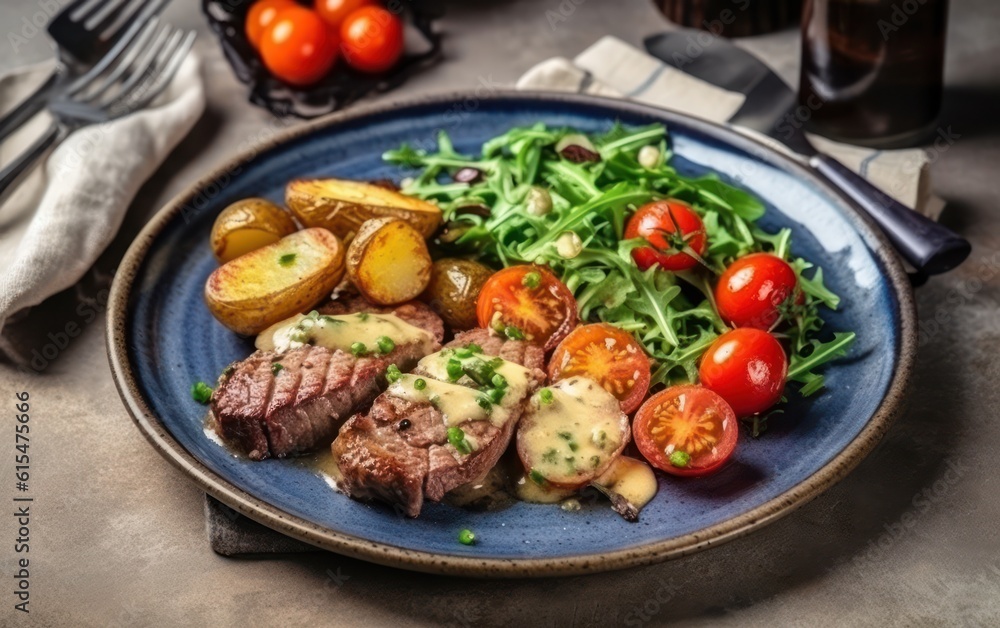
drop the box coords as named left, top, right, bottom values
left=333, top=329, right=545, bottom=517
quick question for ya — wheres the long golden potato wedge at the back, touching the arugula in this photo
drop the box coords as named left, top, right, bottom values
left=285, top=179, right=441, bottom=242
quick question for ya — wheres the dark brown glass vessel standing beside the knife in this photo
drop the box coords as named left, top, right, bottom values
left=799, top=0, right=948, bottom=145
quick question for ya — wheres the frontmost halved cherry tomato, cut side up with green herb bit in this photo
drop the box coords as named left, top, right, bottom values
left=632, top=386, right=739, bottom=476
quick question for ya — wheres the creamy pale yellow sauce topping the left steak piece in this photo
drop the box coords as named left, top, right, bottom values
left=255, top=312, right=434, bottom=353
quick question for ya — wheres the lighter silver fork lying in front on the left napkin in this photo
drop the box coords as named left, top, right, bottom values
left=0, top=18, right=195, bottom=200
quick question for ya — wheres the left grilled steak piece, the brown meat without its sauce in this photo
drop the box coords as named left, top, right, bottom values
left=211, top=299, right=444, bottom=460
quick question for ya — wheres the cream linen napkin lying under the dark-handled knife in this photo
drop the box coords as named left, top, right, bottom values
left=517, top=36, right=944, bottom=220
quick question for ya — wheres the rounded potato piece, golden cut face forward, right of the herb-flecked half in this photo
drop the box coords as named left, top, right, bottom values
left=347, top=218, right=431, bottom=305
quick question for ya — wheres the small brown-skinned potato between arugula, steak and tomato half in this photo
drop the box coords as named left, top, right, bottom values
left=421, top=258, right=493, bottom=330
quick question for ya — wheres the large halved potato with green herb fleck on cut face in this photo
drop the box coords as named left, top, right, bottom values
left=205, top=229, right=345, bottom=335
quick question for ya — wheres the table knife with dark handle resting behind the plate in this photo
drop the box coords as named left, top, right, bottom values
left=645, top=30, right=972, bottom=275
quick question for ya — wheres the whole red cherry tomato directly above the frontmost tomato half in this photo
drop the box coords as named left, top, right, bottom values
left=698, top=327, right=788, bottom=417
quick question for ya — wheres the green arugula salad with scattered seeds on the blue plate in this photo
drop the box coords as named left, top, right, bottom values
left=384, top=124, right=855, bottom=431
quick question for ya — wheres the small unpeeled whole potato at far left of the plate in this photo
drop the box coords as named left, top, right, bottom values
left=211, top=198, right=298, bottom=264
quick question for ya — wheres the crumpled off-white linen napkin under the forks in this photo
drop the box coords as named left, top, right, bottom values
left=0, top=52, right=205, bottom=331
